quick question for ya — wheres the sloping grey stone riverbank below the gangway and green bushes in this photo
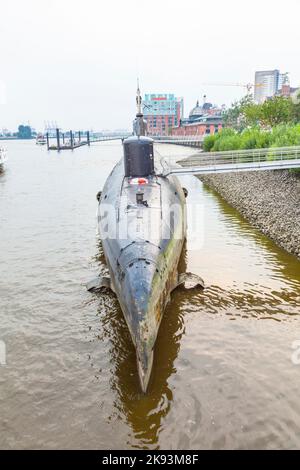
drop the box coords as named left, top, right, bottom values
left=199, top=170, right=300, bottom=258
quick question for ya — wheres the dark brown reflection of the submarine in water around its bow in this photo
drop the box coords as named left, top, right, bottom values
left=96, top=242, right=189, bottom=448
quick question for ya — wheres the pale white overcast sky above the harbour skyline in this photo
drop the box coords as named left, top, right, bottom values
left=0, top=0, right=300, bottom=130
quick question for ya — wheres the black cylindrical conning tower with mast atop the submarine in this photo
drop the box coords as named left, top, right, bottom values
left=123, top=80, right=154, bottom=178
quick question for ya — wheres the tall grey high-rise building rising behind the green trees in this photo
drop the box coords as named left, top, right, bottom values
left=254, top=69, right=286, bottom=103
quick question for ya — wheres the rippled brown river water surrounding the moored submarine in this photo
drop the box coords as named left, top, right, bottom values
left=0, top=141, right=300, bottom=449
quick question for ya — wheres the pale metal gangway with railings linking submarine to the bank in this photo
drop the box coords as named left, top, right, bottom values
left=163, top=146, right=300, bottom=175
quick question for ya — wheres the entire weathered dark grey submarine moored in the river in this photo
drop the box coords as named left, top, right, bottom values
left=87, top=86, right=204, bottom=393
